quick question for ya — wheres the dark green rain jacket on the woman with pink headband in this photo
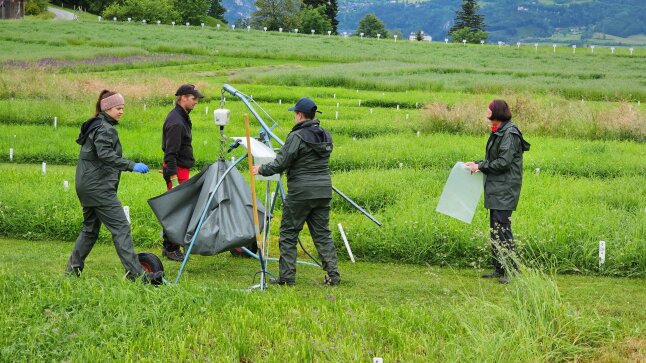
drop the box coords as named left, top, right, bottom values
left=76, top=112, right=135, bottom=207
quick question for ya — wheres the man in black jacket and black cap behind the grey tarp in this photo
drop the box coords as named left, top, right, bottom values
left=162, top=84, right=204, bottom=261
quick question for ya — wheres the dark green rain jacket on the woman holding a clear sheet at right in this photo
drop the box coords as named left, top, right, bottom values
left=478, top=121, right=530, bottom=211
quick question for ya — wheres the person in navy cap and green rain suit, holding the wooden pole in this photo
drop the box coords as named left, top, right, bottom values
left=252, top=98, right=341, bottom=285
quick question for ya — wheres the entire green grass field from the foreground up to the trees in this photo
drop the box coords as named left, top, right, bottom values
left=0, top=17, right=646, bottom=362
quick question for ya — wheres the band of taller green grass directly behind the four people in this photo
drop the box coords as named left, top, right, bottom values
left=0, top=164, right=646, bottom=276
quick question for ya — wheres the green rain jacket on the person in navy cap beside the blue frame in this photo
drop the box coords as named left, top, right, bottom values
left=258, top=119, right=333, bottom=200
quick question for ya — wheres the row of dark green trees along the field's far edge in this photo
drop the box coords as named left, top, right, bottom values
left=28, top=0, right=487, bottom=43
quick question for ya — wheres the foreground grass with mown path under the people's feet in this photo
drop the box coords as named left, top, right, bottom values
left=0, top=239, right=646, bottom=362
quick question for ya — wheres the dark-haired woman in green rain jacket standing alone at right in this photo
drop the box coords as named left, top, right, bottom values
left=465, top=100, right=530, bottom=284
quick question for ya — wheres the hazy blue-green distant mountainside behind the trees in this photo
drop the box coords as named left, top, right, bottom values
left=223, top=0, right=646, bottom=44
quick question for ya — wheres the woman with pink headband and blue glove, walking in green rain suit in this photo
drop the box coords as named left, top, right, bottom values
left=67, top=90, right=163, bottom=283
